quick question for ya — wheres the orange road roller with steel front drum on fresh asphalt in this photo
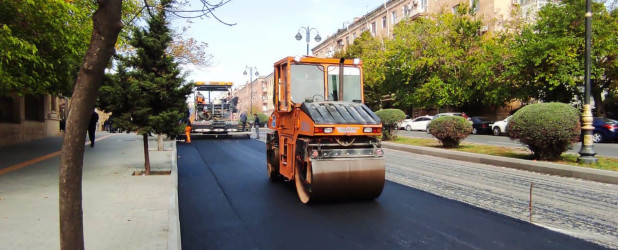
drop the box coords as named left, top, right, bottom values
left=266, top=57, right=384, bottom=203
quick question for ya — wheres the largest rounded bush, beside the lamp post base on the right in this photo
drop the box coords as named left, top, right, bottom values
left=507, top=102, right=581, bottom=161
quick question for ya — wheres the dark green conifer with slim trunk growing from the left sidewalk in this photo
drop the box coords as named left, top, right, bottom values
left=100, top=0, right=192, bottom=175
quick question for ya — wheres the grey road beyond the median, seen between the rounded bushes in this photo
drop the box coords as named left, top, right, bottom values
left=397, top=130, right=618, bottom=157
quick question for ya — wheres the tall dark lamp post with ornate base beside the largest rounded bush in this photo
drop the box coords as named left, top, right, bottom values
left=577, top=0, right=598, bottom=164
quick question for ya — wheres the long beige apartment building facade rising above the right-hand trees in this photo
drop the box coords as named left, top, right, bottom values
left=311, top=0, right=550, bottom=57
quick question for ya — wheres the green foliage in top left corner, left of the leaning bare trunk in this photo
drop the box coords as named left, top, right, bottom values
left=0, top=0, right=92, bottom=96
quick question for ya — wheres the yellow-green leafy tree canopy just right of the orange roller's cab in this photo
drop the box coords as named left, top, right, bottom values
left=384, top=5, right=509, bottom=113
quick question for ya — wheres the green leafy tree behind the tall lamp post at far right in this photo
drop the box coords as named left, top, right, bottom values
left=506, top=0, right=618, bottom=116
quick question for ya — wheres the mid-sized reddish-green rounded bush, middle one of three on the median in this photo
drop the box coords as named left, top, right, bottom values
left=427, top=116, right=472, bottom=148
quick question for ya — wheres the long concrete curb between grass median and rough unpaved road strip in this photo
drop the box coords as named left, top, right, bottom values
left=382, top=141, right=618, bottom=185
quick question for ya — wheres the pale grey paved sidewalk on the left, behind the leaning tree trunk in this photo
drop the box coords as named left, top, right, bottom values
left=0, top=132, right=180, bottom=249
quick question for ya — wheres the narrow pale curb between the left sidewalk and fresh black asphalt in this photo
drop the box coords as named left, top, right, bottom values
left=167, top=141, right=182, bottom=250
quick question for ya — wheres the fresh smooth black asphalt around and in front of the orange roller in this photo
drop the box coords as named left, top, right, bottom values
left=178, top=139, right=602, bottom=249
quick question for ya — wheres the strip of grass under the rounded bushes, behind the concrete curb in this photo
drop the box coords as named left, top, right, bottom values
left=393, top=136, right=618, bottom=171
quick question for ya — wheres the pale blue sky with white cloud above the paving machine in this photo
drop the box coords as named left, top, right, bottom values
left=172, top=0, right=384, bottom=90
